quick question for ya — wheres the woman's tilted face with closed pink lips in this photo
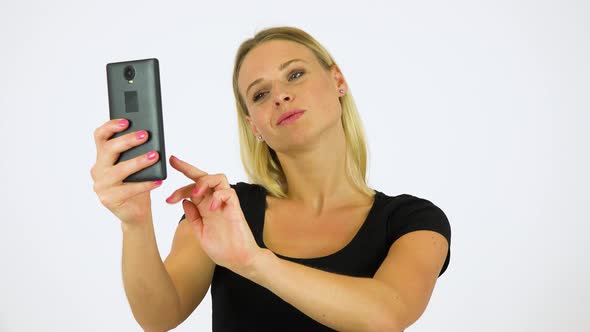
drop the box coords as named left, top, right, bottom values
left=238, top=40, right=347, bottom=152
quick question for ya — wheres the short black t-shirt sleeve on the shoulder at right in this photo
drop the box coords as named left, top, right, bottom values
left=388, top=195, right=451, bottom=276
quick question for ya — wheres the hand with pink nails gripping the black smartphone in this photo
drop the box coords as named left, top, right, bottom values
left=90, top=119, right=162, bottom=225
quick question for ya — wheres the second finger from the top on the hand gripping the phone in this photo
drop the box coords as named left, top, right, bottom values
left=96, top=130, right=149, bottom=167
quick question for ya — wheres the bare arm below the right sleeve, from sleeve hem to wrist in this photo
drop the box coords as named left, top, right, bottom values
left=243, top=231, right=448, bottom=331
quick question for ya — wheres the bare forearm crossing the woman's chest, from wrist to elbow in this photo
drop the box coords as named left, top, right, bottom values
left=244, top=250, right=405, bottom=331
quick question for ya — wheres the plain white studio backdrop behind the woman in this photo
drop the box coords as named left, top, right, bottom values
left=0, top=0, right=590, bottom=332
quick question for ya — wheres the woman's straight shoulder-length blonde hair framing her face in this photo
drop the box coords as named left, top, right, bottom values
left=233, top=27, right=374, bottom=198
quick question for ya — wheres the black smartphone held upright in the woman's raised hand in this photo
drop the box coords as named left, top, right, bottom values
left=107, top=59, right=166, bottom=182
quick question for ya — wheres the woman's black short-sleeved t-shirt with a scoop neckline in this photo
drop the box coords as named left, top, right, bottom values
left=180, top=182, right=451, bottom=332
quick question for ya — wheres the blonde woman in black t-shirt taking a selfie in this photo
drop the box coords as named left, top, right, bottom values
left=92, top=27, right=450, bottom=331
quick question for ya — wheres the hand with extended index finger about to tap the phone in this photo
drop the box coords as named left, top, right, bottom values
left=166, top=156, right=263, bottom=276
